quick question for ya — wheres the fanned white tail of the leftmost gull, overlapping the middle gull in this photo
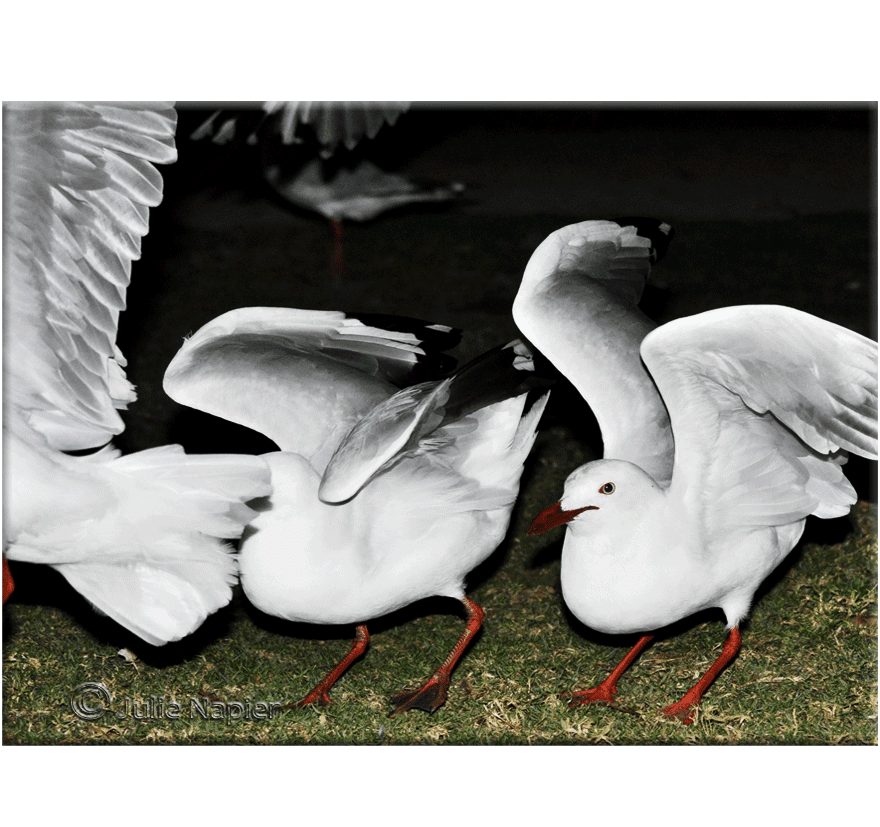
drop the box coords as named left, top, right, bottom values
left=63, top=445, right=271, bottom=646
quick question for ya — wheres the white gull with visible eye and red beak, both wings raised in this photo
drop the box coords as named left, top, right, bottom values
left=513, top=221, right=877, bottom=724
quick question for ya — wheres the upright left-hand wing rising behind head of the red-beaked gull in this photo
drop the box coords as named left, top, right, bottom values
left=513, top=218, right=673, bottom=485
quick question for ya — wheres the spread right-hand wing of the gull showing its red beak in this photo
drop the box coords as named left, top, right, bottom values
left=641, top=305, right=877, bottom=531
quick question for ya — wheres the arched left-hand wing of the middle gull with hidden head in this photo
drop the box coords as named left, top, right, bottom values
left=164, top=307, right=457, bottom=471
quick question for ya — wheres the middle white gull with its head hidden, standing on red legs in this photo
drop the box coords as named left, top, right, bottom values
left=164, top=307, right=549, bottom=716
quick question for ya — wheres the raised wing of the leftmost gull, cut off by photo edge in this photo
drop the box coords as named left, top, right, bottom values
left=3, top=101, right=177, bottom=450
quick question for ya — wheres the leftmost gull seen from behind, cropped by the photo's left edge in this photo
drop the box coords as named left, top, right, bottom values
left=3, top=101, right=271, bottom=646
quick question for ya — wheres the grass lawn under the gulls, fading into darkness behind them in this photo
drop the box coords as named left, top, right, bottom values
left=3, top=191, right=877, bottom=744
